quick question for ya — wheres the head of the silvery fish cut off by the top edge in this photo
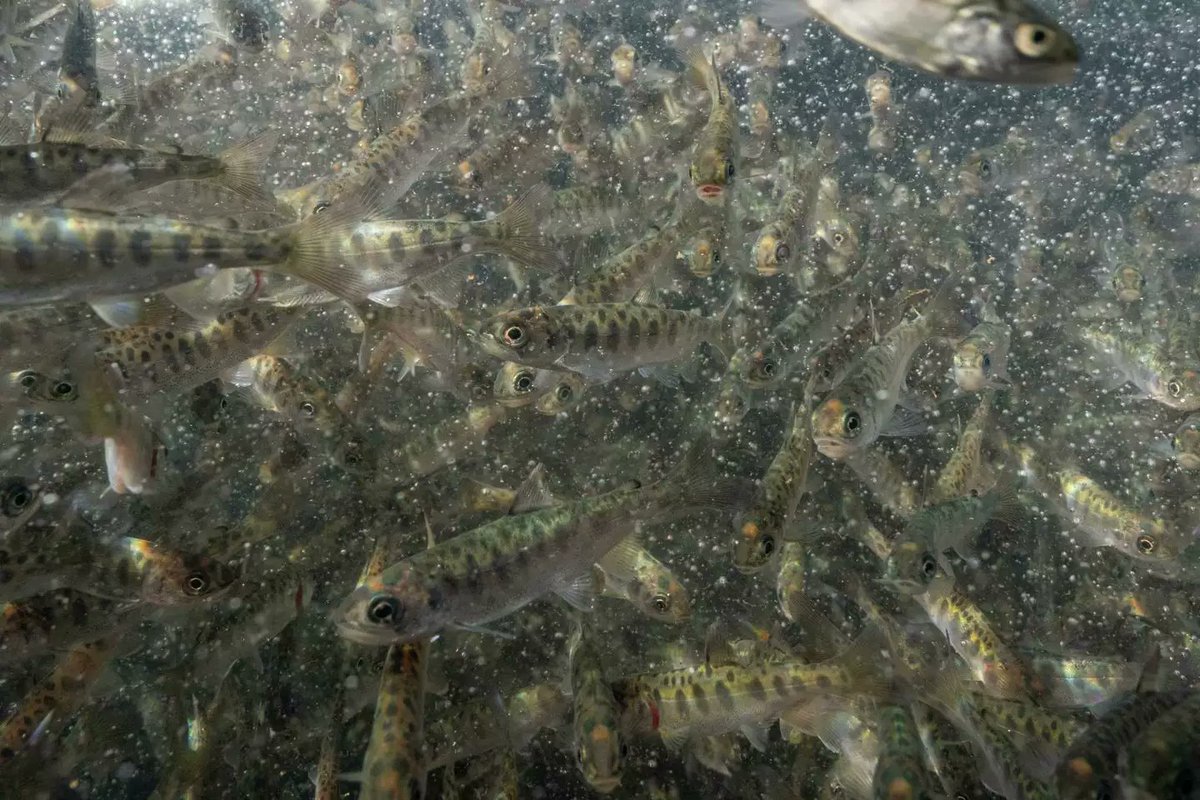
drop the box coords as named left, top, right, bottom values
left=929, top=0, right=1079, bottom=85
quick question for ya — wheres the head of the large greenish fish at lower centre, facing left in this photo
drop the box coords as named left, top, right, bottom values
left=334, top=566, right=432, bottom=645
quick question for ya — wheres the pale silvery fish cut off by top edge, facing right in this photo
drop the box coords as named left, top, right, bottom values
left=764, top=0, right=1079, bottom=84
